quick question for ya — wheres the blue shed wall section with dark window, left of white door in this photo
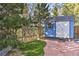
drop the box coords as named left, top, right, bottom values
left=45, top=22, right=56, bottom=37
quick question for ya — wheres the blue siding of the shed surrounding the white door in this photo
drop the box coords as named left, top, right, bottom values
left=44, top=16, right=74, bottom=38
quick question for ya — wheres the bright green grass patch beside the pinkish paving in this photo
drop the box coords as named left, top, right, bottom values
left=18, top=40, right=46, bottom=56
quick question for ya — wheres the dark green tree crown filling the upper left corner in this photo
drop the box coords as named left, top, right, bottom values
left=0, top=4, right=26, bottom=39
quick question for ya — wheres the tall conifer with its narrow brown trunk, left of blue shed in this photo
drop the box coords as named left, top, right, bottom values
left=35, top=3, right=49, bottom=38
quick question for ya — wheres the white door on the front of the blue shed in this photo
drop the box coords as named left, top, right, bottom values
left=56, top=21, right=69, bottom=38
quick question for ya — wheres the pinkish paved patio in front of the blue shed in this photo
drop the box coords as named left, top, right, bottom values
left=44, top=40, right=79, bottom=56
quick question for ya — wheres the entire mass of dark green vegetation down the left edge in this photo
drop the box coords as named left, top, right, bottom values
left=0, top=3, right=26, bottom=50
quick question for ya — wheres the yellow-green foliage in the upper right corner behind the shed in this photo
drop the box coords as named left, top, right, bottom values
left=62, top=3, right=79, bottom=26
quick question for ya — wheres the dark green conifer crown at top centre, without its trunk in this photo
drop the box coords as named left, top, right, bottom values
left=35, top=3, right=49, bottom=23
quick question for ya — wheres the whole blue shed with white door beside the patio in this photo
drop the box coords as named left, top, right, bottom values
left=44, top=16, right=74, bottom=38
